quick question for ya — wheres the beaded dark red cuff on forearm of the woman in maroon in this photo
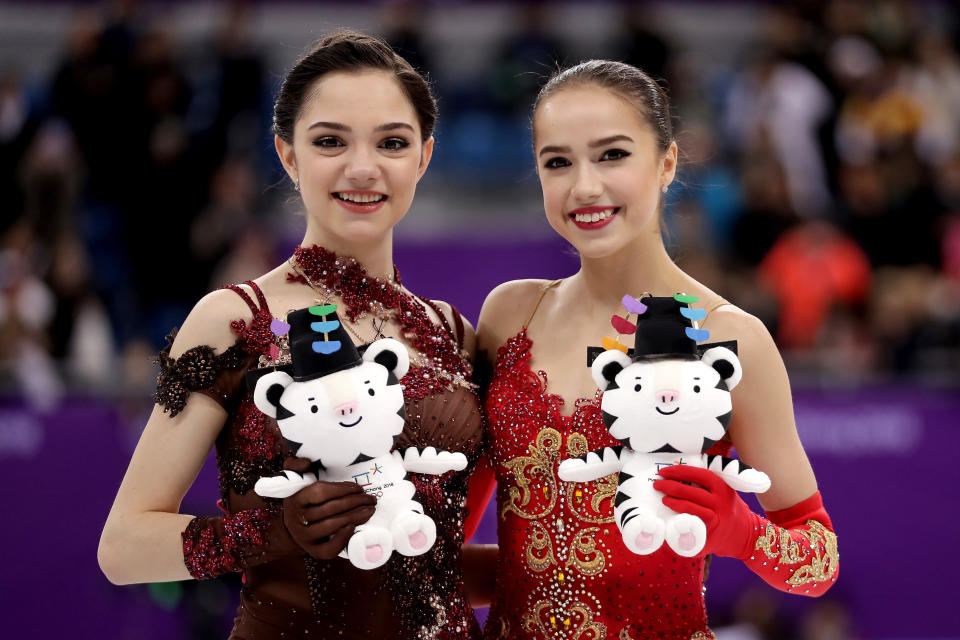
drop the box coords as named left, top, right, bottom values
left=181, top=506, right=279, bottom=580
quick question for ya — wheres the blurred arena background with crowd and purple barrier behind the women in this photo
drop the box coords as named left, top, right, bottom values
left=0, top=0, right=960, bottom=640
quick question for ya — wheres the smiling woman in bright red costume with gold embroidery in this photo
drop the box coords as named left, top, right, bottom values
left=477, top=60, right=837, bottom=640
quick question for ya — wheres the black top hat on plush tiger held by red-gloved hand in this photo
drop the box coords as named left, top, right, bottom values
left=633, top=293, right=710, bottom=360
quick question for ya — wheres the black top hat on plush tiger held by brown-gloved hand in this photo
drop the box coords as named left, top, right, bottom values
left=287, top=304, right=361, bottom=381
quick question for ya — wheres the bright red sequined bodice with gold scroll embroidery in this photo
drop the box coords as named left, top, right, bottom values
left=484, top=329, right=714, bottom=640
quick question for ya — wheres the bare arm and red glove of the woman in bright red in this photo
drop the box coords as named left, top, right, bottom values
left=654, top=307, right=839, bottom=596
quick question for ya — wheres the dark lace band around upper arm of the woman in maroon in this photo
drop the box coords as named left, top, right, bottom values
left=154, top=329, right=248, bottom=417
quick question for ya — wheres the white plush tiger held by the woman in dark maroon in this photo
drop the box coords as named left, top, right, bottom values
left=253, top=305, right=467, bottom=569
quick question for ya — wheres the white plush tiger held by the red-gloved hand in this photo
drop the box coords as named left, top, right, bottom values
left=558, top=294, right=770, bottom=557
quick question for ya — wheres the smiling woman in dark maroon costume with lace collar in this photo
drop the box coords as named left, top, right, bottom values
left=98, top=32, right=482, bottom=638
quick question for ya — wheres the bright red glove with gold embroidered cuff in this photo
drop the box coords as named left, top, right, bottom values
left=653, top=465, right=839, bottom=596
